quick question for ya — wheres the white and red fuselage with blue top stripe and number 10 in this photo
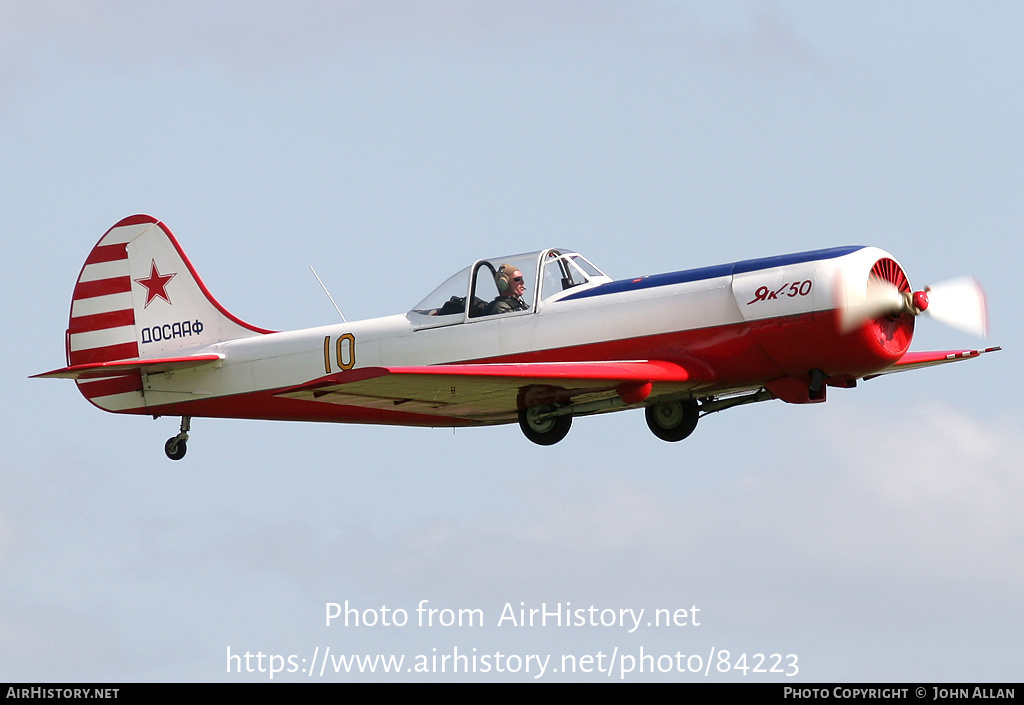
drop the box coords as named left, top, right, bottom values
left=116, top=241, right=913, bottom=425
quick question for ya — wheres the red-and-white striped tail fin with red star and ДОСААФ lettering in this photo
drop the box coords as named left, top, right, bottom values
left=50, top=215, right=270, bottom=413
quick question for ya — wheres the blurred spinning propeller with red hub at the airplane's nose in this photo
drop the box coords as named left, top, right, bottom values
left=841, top=270, right=988, bottom=338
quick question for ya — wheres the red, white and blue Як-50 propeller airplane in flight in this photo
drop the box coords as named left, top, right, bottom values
left=34, top=215, right=1000, bottom=460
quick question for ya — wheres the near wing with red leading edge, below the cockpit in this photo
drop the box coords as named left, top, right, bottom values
left=278, top=360, right=708, bottom=423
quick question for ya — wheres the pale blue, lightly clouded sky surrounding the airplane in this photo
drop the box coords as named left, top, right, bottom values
left=0, top=0, right=1024, bottom=685
